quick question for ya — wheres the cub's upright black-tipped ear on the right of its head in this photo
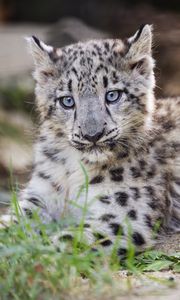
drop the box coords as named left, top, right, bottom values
left=127, top=24, right=152, bottom=58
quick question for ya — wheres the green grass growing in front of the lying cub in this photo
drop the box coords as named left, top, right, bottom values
left=0, top=182, right=180, bottom=300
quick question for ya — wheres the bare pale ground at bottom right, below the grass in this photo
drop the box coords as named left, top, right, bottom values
left=80, top=271, right=180, bottom=300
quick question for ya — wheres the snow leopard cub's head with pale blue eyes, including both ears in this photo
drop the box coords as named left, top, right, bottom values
left=29, top=25, right=154, bottom=160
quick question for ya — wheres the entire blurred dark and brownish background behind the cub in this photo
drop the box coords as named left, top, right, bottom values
left=0, top=0, right=180, bottom=201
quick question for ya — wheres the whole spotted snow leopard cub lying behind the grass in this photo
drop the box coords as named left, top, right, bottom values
left=1, top=25, right=180, bottom=254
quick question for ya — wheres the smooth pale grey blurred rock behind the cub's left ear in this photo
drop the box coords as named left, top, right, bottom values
left=0, top=24, right=47, bottom=80
